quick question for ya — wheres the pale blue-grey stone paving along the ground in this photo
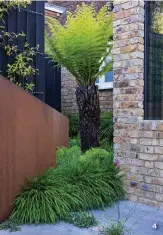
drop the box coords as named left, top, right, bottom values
left=0, top=200, right=163, bottom=235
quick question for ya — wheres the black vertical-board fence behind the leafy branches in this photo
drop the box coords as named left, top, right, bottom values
left=0, top=1, right=61, bottom=111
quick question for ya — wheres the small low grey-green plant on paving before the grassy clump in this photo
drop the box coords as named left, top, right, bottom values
left=65, top=211, right=97, bottom=228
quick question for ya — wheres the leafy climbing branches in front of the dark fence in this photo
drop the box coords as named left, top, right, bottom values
left=0, top=0, right=39, bottom=92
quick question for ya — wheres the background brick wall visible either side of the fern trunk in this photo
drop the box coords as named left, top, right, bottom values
left=61, top=68, right=113, bottom=113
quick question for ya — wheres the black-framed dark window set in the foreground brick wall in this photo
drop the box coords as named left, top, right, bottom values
left=144, top=1, right=163, bottom=120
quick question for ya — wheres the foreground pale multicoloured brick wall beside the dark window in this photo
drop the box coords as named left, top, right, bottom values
left=113, top=0, right=163, bottom=207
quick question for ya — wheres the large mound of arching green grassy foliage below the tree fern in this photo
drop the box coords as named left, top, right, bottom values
left=11, top=147, right=124, bottom=223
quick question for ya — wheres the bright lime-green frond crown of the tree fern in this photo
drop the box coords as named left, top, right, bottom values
left=45, top=3, right=113, bottom=86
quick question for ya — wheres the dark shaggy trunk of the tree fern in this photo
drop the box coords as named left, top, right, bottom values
left=76, top=84, right=100, bottom=152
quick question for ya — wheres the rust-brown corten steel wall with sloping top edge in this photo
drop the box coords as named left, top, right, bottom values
left=0, top=76, right=68, bottom=221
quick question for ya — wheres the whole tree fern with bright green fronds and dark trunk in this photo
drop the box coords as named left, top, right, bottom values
left=45, top=3, right=112, bottom=151
